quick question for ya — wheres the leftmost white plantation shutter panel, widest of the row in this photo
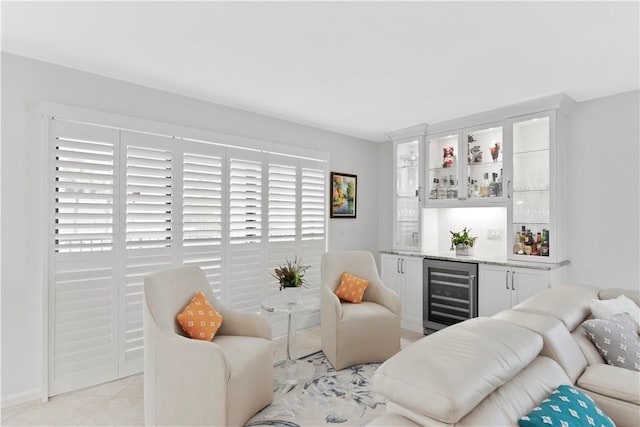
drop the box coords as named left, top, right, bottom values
left=48, top=120, right=118, bottom=394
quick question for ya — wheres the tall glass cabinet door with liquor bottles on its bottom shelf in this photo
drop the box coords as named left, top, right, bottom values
left=510, top=115, right=554, bottom=262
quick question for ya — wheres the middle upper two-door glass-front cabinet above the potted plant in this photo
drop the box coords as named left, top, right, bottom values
left=425, top=125, right=507, bottom=206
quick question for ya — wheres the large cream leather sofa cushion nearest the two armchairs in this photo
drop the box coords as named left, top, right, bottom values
left=374, top=318, right=542, bottom=424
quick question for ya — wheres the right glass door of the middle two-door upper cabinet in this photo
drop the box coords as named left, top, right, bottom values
left=463, top=125, right=505, bottom=201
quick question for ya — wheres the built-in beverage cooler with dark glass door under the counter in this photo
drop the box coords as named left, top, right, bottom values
left=422, top=259, right=478, bottom=335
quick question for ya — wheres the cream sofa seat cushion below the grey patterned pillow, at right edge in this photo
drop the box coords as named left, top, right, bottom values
left=577, top=364, right=640, bottom=405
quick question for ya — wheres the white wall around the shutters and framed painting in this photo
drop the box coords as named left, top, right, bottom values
left=0, top=53, right=379, bottom=405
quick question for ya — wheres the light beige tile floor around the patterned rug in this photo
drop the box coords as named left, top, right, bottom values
left=5, top=327, right=422, bottom=426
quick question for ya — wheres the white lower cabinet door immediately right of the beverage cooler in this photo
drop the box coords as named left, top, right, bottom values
left=478, top=264, right=511, bottom=316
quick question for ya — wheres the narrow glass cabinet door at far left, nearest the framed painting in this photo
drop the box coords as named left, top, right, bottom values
left=394, top=139, right=422, bottom=250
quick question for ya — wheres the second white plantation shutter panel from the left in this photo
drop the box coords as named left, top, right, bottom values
left=120, top=131, right=177, bottom=375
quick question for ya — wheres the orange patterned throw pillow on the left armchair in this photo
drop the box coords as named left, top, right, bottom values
left=177, top=292, right=222, bottom=341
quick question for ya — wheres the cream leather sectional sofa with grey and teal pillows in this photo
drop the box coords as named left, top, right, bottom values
left=370, top=286, right=640, bottom=427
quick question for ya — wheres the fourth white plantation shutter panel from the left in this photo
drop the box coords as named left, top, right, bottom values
left=225, top=150, right=266, bottom=312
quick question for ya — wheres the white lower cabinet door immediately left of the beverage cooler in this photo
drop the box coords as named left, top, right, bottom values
left=400, top=257, right=423, bottom=332
